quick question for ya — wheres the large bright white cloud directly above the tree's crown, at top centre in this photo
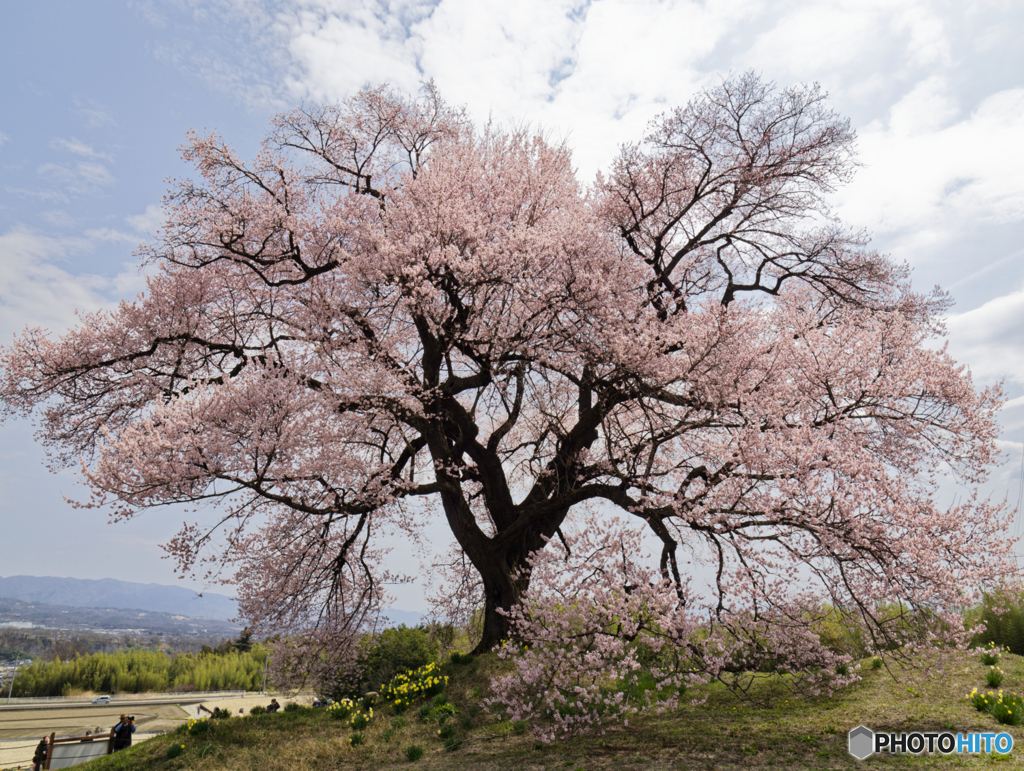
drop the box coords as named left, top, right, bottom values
left=279, top=0, right=759, bottom=179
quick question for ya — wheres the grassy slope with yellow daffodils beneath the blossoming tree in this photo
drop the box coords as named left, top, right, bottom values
left=72, top=655, right=1024, bottom=771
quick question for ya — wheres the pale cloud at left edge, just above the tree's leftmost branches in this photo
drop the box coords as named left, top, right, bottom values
left=0, top=227, right=144, bottom=344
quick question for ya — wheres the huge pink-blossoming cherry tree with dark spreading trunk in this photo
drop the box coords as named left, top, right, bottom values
left=2, top=75, right=1010, bottom=688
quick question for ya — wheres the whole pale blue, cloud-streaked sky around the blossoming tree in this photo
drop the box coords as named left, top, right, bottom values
left=0, top=0, right=1024, bottom=609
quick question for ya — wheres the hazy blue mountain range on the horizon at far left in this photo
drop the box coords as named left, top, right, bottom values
left=0, top=575, right=238, bottom=620
